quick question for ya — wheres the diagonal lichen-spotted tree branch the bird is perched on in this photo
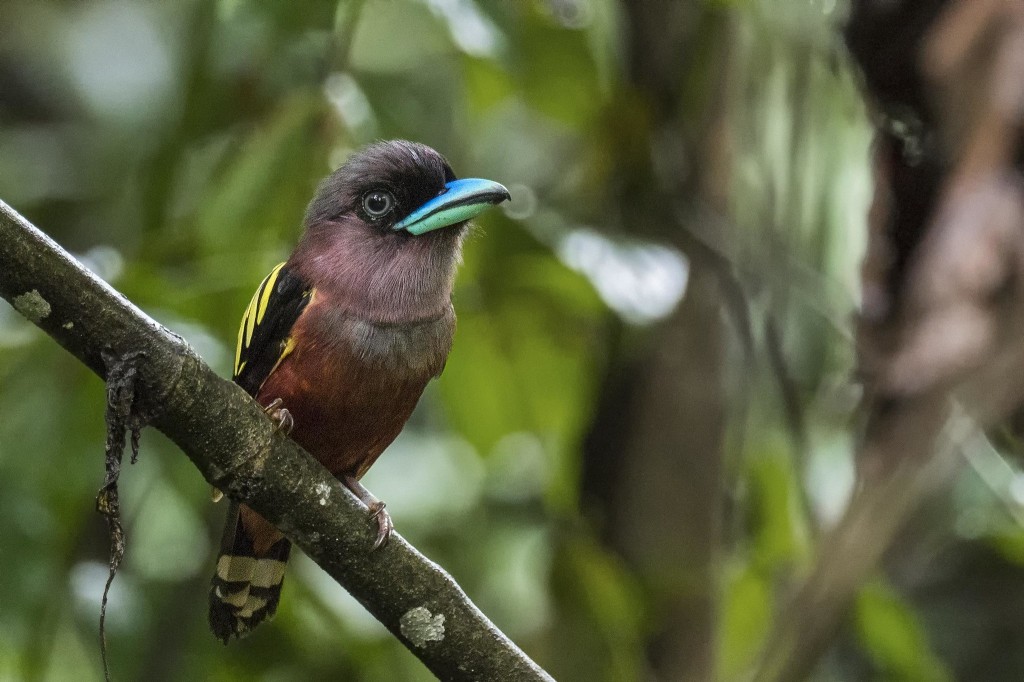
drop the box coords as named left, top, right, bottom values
left=0, top=201, right=552, bottom=680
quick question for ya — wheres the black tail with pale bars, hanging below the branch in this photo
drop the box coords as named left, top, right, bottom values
left=210, top=502, right=292, bottom=644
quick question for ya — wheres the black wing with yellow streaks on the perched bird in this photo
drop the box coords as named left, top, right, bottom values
left=232, top=263, right=313, bottom=396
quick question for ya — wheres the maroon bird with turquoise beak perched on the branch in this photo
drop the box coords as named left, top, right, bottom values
left=209, top=140, right=511, bottom=644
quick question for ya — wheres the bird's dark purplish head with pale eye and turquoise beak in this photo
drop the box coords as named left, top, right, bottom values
left=292, top=140, right=509, bottom=321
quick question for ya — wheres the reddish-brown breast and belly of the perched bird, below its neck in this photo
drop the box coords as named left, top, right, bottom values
left=257, top=292, right=455, bottom=477
